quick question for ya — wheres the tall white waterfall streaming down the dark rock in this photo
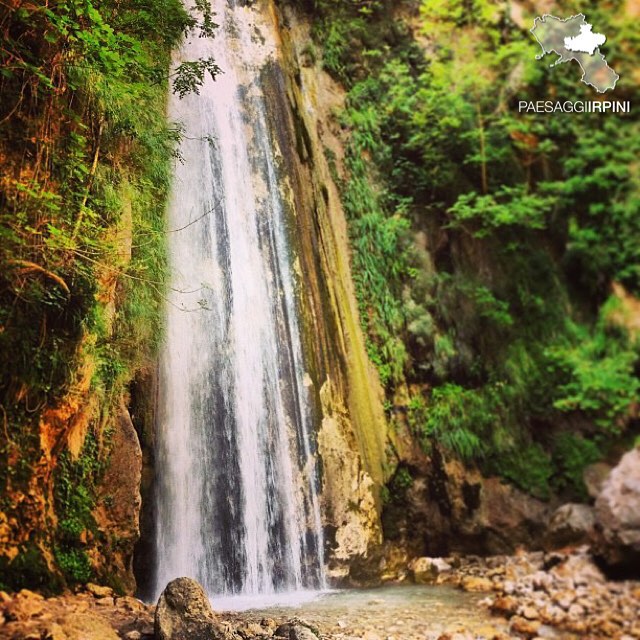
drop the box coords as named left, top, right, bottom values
left=155, top=0, right=324, bottom=597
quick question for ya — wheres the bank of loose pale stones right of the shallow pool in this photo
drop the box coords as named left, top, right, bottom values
left=414, top=547, right=640, bottom=640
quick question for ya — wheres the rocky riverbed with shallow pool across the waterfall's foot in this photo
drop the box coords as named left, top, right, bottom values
left=0, top=547, right=640, bottom=640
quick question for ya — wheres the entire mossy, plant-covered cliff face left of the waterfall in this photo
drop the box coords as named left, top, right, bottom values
left=0, top=0, right=190, bottom=591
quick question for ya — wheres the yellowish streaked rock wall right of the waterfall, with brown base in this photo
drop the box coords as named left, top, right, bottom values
left=239, top=3, right=568, bottom=583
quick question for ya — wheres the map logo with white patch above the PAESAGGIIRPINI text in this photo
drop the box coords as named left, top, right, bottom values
left=531, top=13, right=620, bottom=93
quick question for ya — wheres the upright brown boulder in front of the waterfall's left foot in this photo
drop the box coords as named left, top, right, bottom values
left=155, top=578, right=221, bottom=640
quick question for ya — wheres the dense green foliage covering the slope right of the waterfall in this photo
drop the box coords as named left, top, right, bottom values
left=312, top=0, right=640, bottom=497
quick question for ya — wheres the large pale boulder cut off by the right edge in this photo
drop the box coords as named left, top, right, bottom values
left=594, top=447, right=640, bottom=573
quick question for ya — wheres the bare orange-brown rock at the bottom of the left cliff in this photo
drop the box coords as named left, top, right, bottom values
left=0, top=231, right=142, bottom=593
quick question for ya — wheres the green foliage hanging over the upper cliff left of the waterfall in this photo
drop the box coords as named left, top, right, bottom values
left=0, top=0, right=210, bottom=502
